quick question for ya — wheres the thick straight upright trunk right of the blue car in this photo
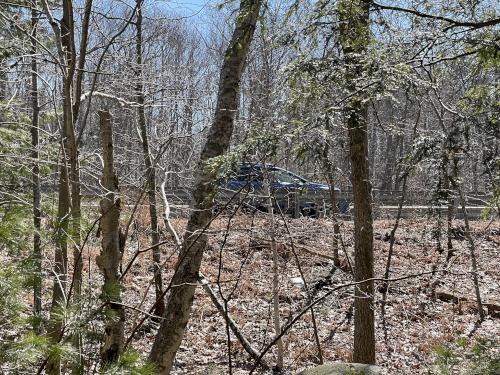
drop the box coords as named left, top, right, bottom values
left=338, top=0, right=375, bottom=364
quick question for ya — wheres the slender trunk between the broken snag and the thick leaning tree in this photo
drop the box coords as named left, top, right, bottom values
left=135, top=0, right=165, bottom=316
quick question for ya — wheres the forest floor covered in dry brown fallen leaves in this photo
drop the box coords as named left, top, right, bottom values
left=110, top=212, right=500, bottom=375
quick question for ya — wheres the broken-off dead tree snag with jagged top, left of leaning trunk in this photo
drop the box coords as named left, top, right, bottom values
left=96, top=111, right=125, bottom=364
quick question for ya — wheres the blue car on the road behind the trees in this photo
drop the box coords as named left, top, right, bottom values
left=216, top=163, right=339, bottom=217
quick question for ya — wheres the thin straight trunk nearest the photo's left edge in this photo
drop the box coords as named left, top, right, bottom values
left=31, top=0, right=42, bottom=331
